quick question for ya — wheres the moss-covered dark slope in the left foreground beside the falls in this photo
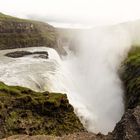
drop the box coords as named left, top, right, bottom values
left=0, top=82, right=84, bottom=138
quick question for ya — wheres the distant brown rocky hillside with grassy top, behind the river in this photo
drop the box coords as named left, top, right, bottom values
left=0, top=13, right=63, bottom=53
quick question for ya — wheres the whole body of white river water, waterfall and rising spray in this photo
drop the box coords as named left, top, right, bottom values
left=0, top=20, right=139, bottom=134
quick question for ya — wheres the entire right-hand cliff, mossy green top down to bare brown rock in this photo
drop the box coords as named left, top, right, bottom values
left=112, top=47, right=140, bottom=140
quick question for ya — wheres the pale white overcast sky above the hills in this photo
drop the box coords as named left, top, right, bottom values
left=0, top=0, right=140, bottom=26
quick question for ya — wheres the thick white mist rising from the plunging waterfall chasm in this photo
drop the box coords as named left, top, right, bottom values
left=58, top=21, right=140, bottom=134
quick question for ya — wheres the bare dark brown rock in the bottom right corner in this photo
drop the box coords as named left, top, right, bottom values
left=112, top=106, right=140, bottom=140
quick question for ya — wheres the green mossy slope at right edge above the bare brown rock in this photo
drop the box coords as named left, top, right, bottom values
left=122, top=47, right=140, bottom=109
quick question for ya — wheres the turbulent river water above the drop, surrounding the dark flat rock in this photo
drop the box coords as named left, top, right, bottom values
left=0, top=47, right=61, bottom=91
